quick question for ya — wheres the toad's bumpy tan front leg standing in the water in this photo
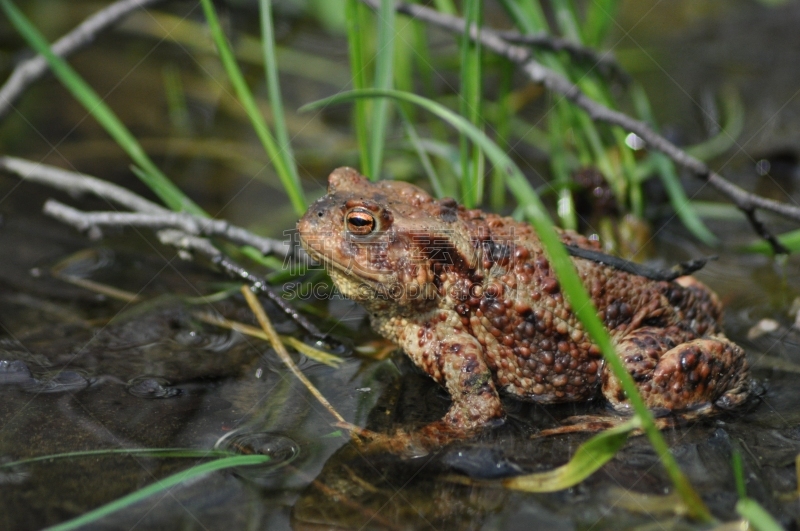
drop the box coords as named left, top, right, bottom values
left=398, top=313, right=503, bottom=438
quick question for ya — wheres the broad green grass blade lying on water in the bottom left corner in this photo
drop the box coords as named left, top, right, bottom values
left=47, top=455, right=270, bottom=531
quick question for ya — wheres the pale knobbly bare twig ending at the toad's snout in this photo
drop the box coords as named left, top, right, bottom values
left=43, top=199, right=291, bottom=256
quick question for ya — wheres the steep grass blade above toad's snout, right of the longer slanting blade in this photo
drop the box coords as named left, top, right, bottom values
left=259, top=0, right=300, bottom=183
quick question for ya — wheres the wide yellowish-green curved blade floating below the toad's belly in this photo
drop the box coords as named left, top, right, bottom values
left=503, top=417, right=641, bottom=492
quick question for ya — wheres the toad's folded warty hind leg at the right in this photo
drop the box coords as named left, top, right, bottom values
left=602, top=328, right=750, bottom=411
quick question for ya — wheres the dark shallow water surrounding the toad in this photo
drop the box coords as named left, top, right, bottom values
left=0, top=0, right=800, bottom=530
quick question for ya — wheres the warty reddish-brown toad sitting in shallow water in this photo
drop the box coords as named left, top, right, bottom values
left=298, top=168, right=749, bottom=433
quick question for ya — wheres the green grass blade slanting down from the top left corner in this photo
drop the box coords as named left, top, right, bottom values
left=0, top=0, right=207, bottom=216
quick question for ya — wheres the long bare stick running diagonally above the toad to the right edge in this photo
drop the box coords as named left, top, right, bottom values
left=361, top=0, right=800, bottom=252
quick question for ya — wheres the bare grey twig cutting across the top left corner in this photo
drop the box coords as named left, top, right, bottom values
left=0, top=0, right=162, bottom=118
